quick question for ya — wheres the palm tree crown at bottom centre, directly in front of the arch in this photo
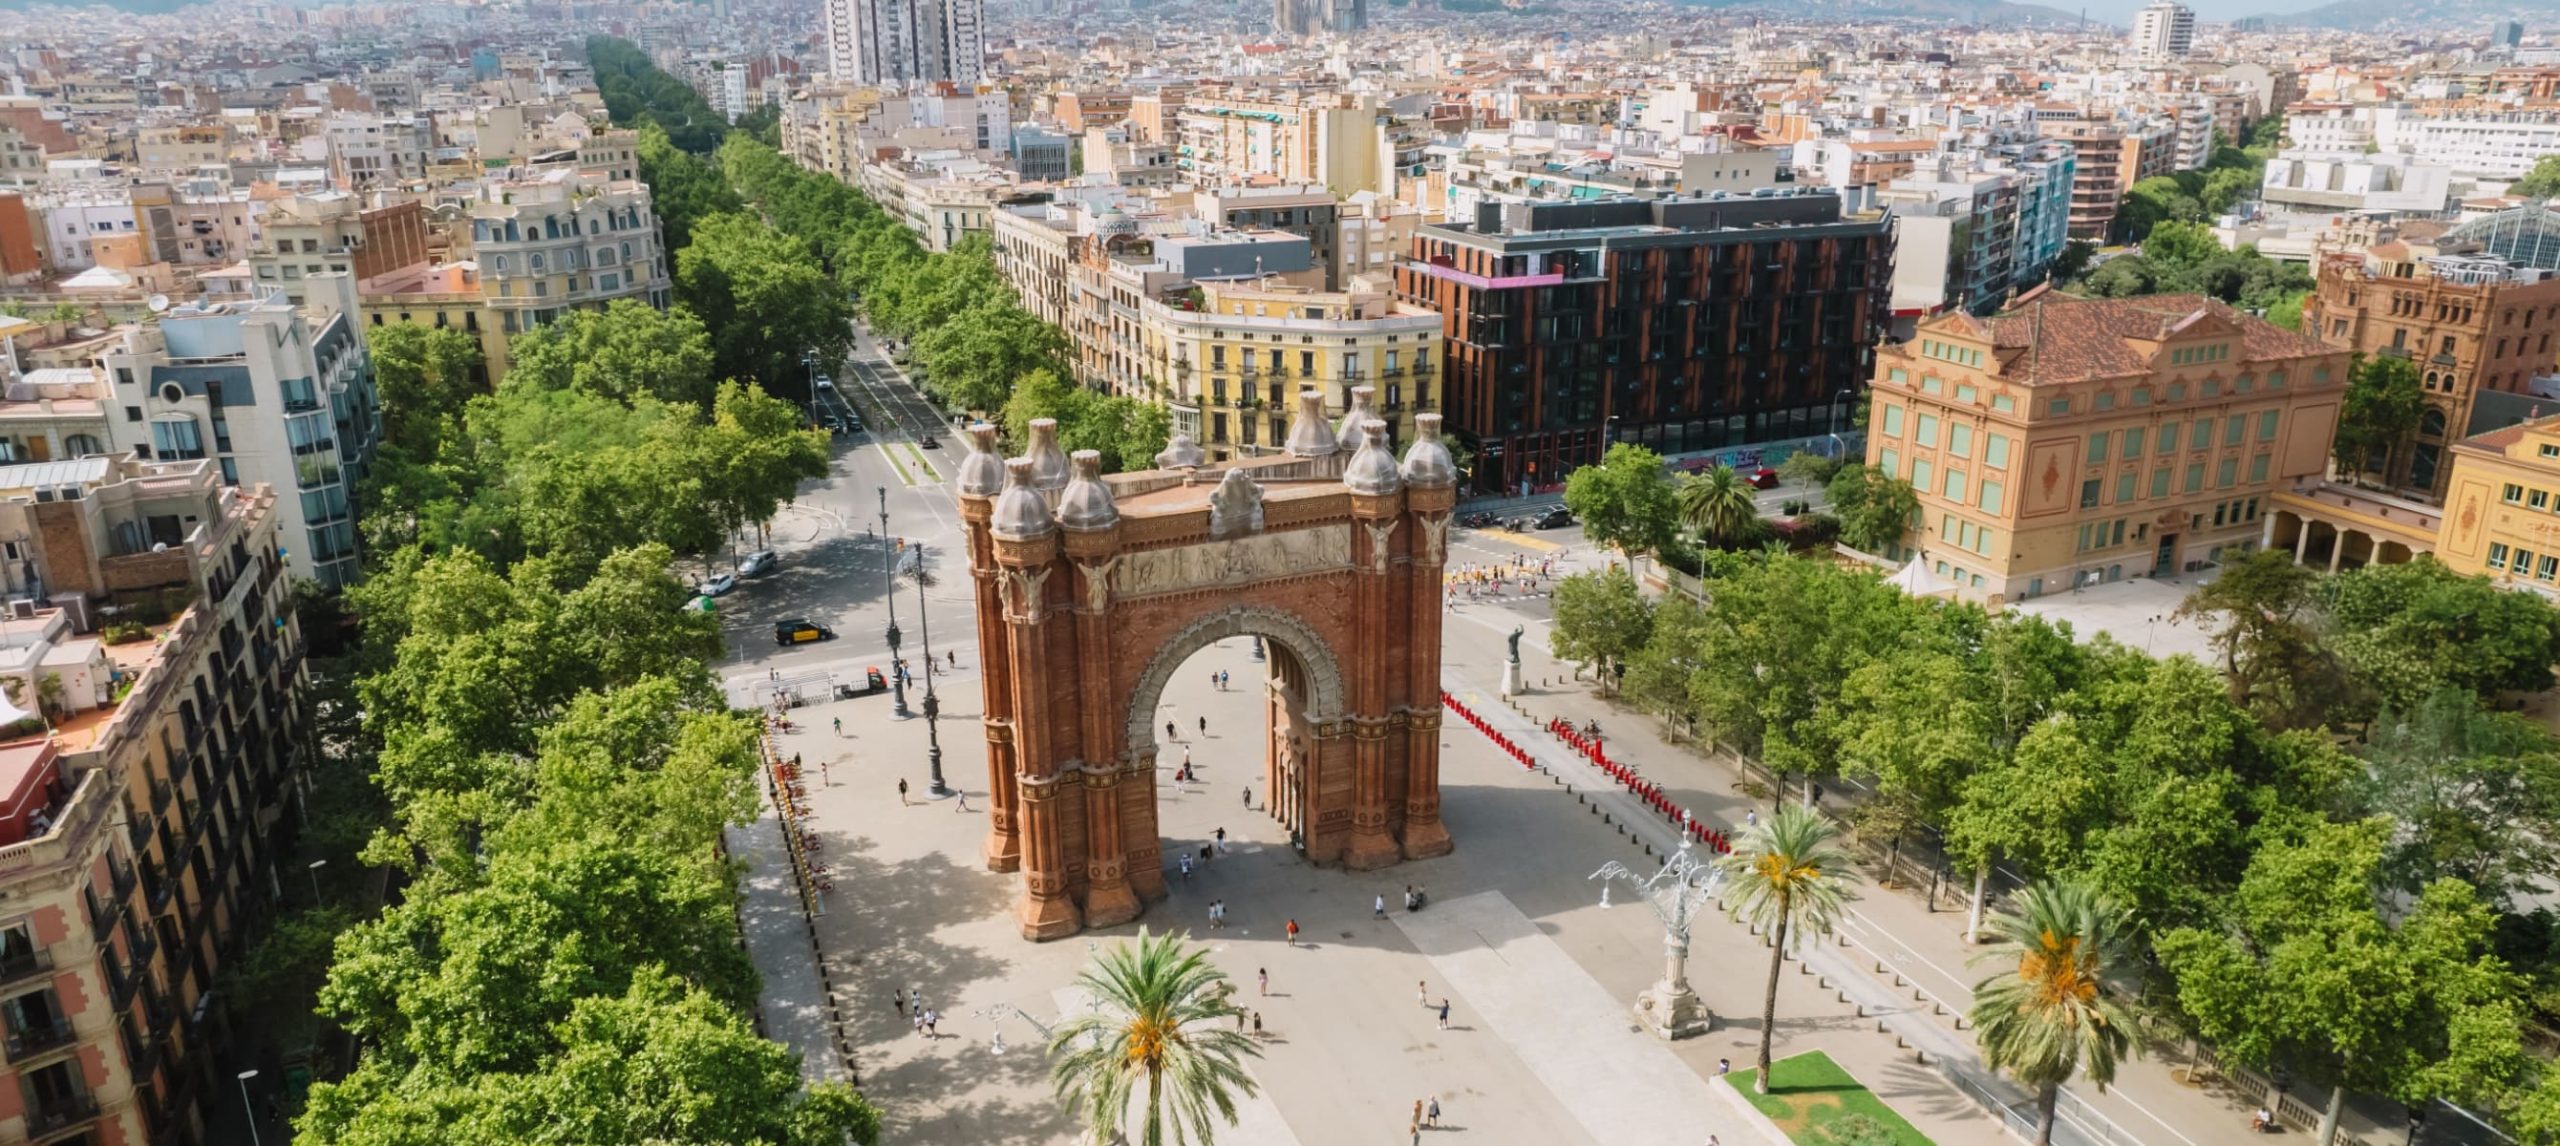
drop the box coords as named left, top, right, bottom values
left=1050, top=929, right=1262, bottom=1146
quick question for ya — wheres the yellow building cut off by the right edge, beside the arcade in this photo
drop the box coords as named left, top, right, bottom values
left=2435, top=417, right=2560, bottom=596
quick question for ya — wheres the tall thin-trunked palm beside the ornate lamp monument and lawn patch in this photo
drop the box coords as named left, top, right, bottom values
left=1715, top=806, right=1859, bottom=1095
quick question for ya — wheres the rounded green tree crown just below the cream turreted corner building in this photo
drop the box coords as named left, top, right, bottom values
left=507, top=299, right=712, bottom=407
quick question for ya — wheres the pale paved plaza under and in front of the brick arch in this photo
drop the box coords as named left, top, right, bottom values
left=748, top=631, right=1992, bottom=1146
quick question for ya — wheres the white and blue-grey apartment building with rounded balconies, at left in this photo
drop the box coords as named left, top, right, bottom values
left=94, top=274, right=381, bottom=586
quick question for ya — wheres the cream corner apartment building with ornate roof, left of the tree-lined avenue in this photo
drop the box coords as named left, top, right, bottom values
left=468, top=169, right=673, bottom=335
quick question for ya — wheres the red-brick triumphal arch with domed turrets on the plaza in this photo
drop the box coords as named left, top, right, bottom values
left=960, top=389, right=1457, bottom=939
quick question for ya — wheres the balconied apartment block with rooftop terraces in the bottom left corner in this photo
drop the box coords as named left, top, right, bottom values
left=0, top=455, right=305, bottom=1143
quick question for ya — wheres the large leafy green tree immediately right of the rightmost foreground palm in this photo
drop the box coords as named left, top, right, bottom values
left=2156, top=821, right=2527, bottom=1143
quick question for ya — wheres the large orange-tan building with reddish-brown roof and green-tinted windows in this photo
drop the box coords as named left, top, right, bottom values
left=1866, top=294, right=2350, bottom=606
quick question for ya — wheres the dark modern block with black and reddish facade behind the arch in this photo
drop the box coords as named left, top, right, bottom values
left=1395, top=189, right=1892, bottom=491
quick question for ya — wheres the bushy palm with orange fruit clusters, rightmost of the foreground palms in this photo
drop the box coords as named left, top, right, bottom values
left=1974, top=883, right=2135, bottom=1146
